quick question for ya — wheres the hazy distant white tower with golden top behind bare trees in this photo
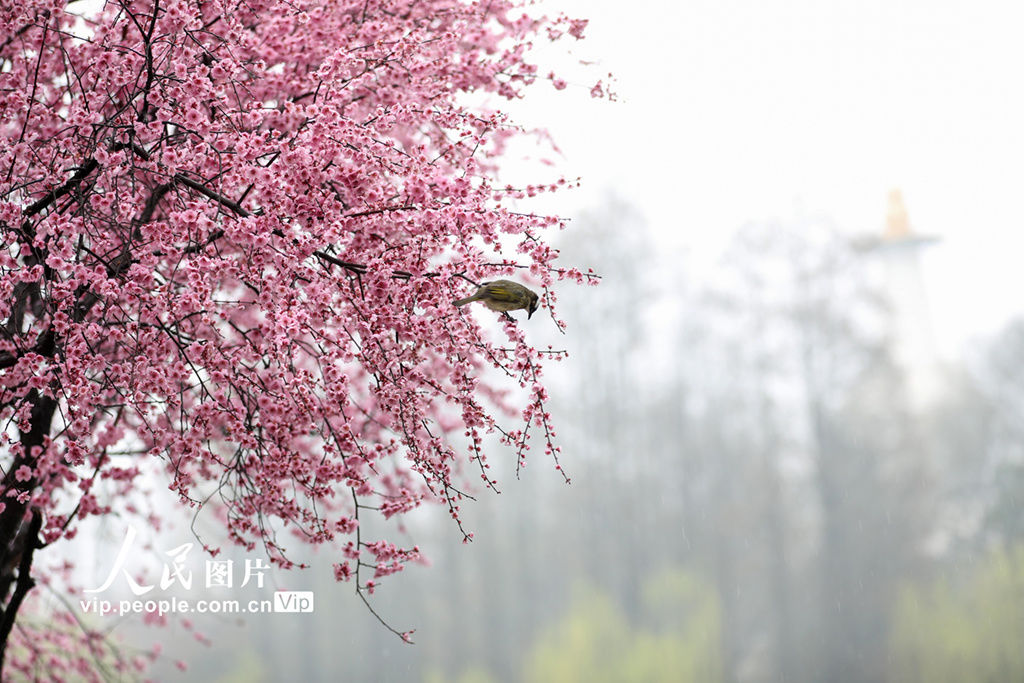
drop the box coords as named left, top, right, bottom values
left=859, top=189, right=938, bottom=410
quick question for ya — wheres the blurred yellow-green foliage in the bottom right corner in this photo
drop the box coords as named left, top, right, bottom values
left=891, top=546, right=1024, bottom=683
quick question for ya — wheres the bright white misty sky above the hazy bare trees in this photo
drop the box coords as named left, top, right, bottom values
left=515, top=0, right=1024, bottom=354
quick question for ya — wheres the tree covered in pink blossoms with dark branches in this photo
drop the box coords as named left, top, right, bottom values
left=0, top=0, right=600, bottom=671
